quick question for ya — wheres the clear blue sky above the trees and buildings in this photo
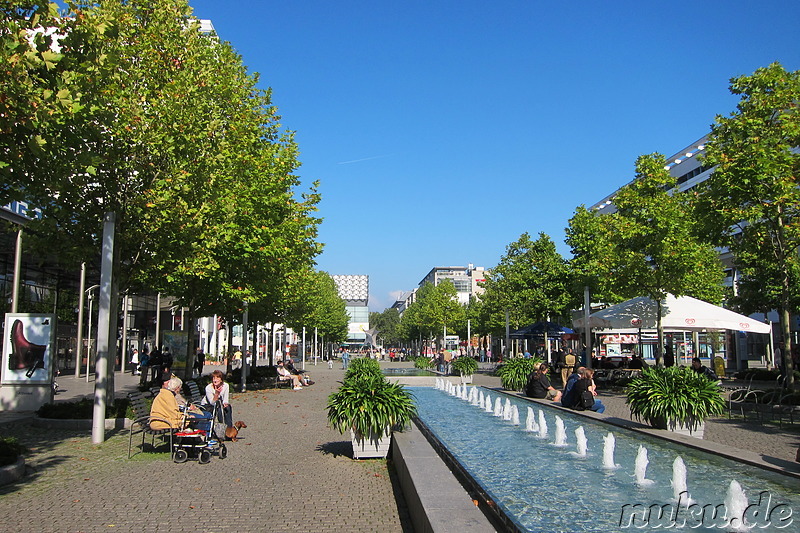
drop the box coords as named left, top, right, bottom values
left=190, top=0, right=800, bottom=311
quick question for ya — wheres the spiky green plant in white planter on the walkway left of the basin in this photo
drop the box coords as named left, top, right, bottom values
left=327, top=375, right=417, bottom=459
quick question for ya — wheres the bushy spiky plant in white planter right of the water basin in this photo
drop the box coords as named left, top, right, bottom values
left=626, top=366, right=725, bottom=439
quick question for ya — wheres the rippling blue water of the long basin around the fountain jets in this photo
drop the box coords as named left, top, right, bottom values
left=411, top=387, right=800, bottom=532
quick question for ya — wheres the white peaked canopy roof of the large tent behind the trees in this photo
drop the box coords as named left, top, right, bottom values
left=572, top=294, right=772, bottom=334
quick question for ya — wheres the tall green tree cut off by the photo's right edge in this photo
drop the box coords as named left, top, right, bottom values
left=697, top=63, right=800, bottom=386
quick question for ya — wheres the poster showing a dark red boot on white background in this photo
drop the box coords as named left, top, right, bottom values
left=2, top=313, right=56, bottom=385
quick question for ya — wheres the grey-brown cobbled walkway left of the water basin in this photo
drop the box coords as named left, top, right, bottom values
left=0, top=365, right=411, bottom=533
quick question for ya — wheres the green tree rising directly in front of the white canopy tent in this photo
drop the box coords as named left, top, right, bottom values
left=568, top=154, right=723, bottom=365
